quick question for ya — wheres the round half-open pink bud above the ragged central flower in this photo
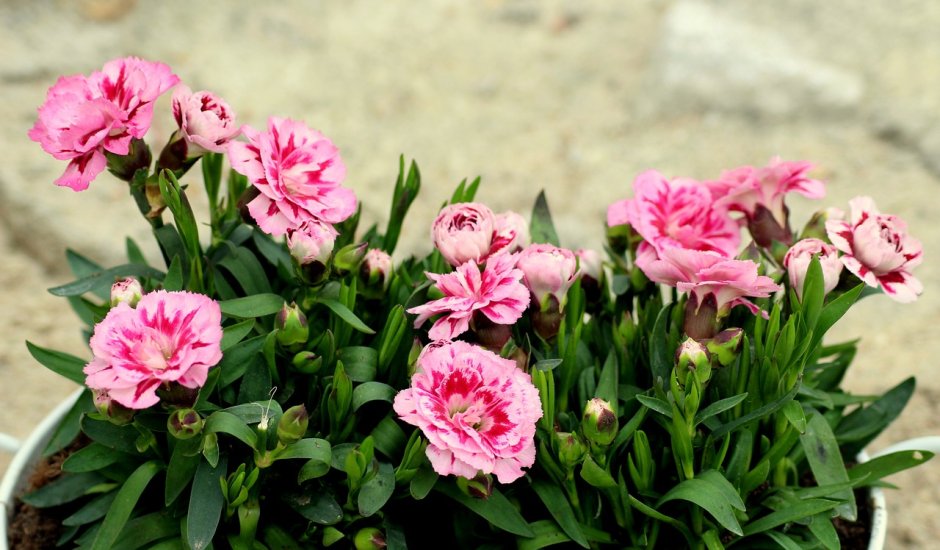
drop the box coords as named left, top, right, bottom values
left=431, top=202, right=496, bottom=267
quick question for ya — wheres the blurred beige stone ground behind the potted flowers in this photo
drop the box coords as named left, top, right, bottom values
left=0, top=0, right=940, bottom=548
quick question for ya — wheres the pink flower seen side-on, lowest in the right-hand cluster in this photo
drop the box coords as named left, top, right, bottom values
left=642, top=248, right=782, bottom=317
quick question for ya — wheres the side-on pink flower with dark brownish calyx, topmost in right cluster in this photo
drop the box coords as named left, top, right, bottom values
left=707, top=157, right=826, bottom=246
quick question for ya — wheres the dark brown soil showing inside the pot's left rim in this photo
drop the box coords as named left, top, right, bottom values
left=9, top=438, right=88, bottom=550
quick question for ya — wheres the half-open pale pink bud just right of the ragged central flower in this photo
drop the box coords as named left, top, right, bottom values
left=516, top=244, right=579, bottom=311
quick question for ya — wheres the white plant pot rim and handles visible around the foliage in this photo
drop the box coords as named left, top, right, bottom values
left=0, top=389, right=940, bottom=550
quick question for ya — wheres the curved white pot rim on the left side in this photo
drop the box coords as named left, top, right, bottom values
left=0, top=388, right=84, bottom=550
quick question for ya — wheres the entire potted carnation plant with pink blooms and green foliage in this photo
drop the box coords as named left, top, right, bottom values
left=16, top=58, right=931, bottom=549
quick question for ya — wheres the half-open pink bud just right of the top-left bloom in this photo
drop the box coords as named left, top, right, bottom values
left=173, top=85, right=241, bottom=157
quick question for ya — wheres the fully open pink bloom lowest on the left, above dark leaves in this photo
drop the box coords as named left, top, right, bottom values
left=84, top=290, right=222, bottom=409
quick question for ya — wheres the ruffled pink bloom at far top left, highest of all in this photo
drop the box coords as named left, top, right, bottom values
left=29, top=57, right=179, bottom=191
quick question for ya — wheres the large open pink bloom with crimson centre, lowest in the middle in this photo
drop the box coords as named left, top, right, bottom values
left=394, top=342, right=542, bottom=483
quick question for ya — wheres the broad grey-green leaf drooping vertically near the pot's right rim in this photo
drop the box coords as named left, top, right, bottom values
left=800, top=411, right=858, bottom=521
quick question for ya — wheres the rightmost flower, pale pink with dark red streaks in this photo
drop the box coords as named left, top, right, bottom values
left=826, top=197, right=924, bottom=302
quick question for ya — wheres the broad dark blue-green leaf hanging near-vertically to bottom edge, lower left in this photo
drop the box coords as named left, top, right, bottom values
left=186, top=455, right=228, bottom=550
